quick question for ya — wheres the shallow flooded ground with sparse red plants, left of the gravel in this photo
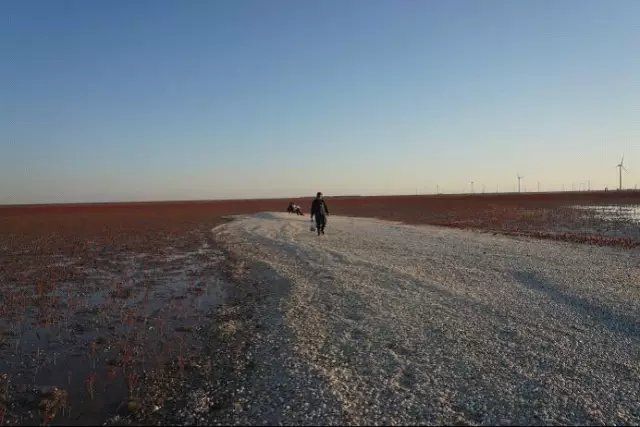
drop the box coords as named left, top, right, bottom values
left=0, top=242, right=224, bottom=424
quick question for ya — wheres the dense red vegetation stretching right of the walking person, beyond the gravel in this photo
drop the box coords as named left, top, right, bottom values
left=330, top=191, right=640, bottom=248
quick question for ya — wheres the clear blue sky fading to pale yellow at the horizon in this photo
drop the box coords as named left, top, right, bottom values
left=0, top=0, right=640, bottom=204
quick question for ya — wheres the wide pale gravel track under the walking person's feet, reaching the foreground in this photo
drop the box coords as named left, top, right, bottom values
left=208, top=213, right=640, bottom=424
